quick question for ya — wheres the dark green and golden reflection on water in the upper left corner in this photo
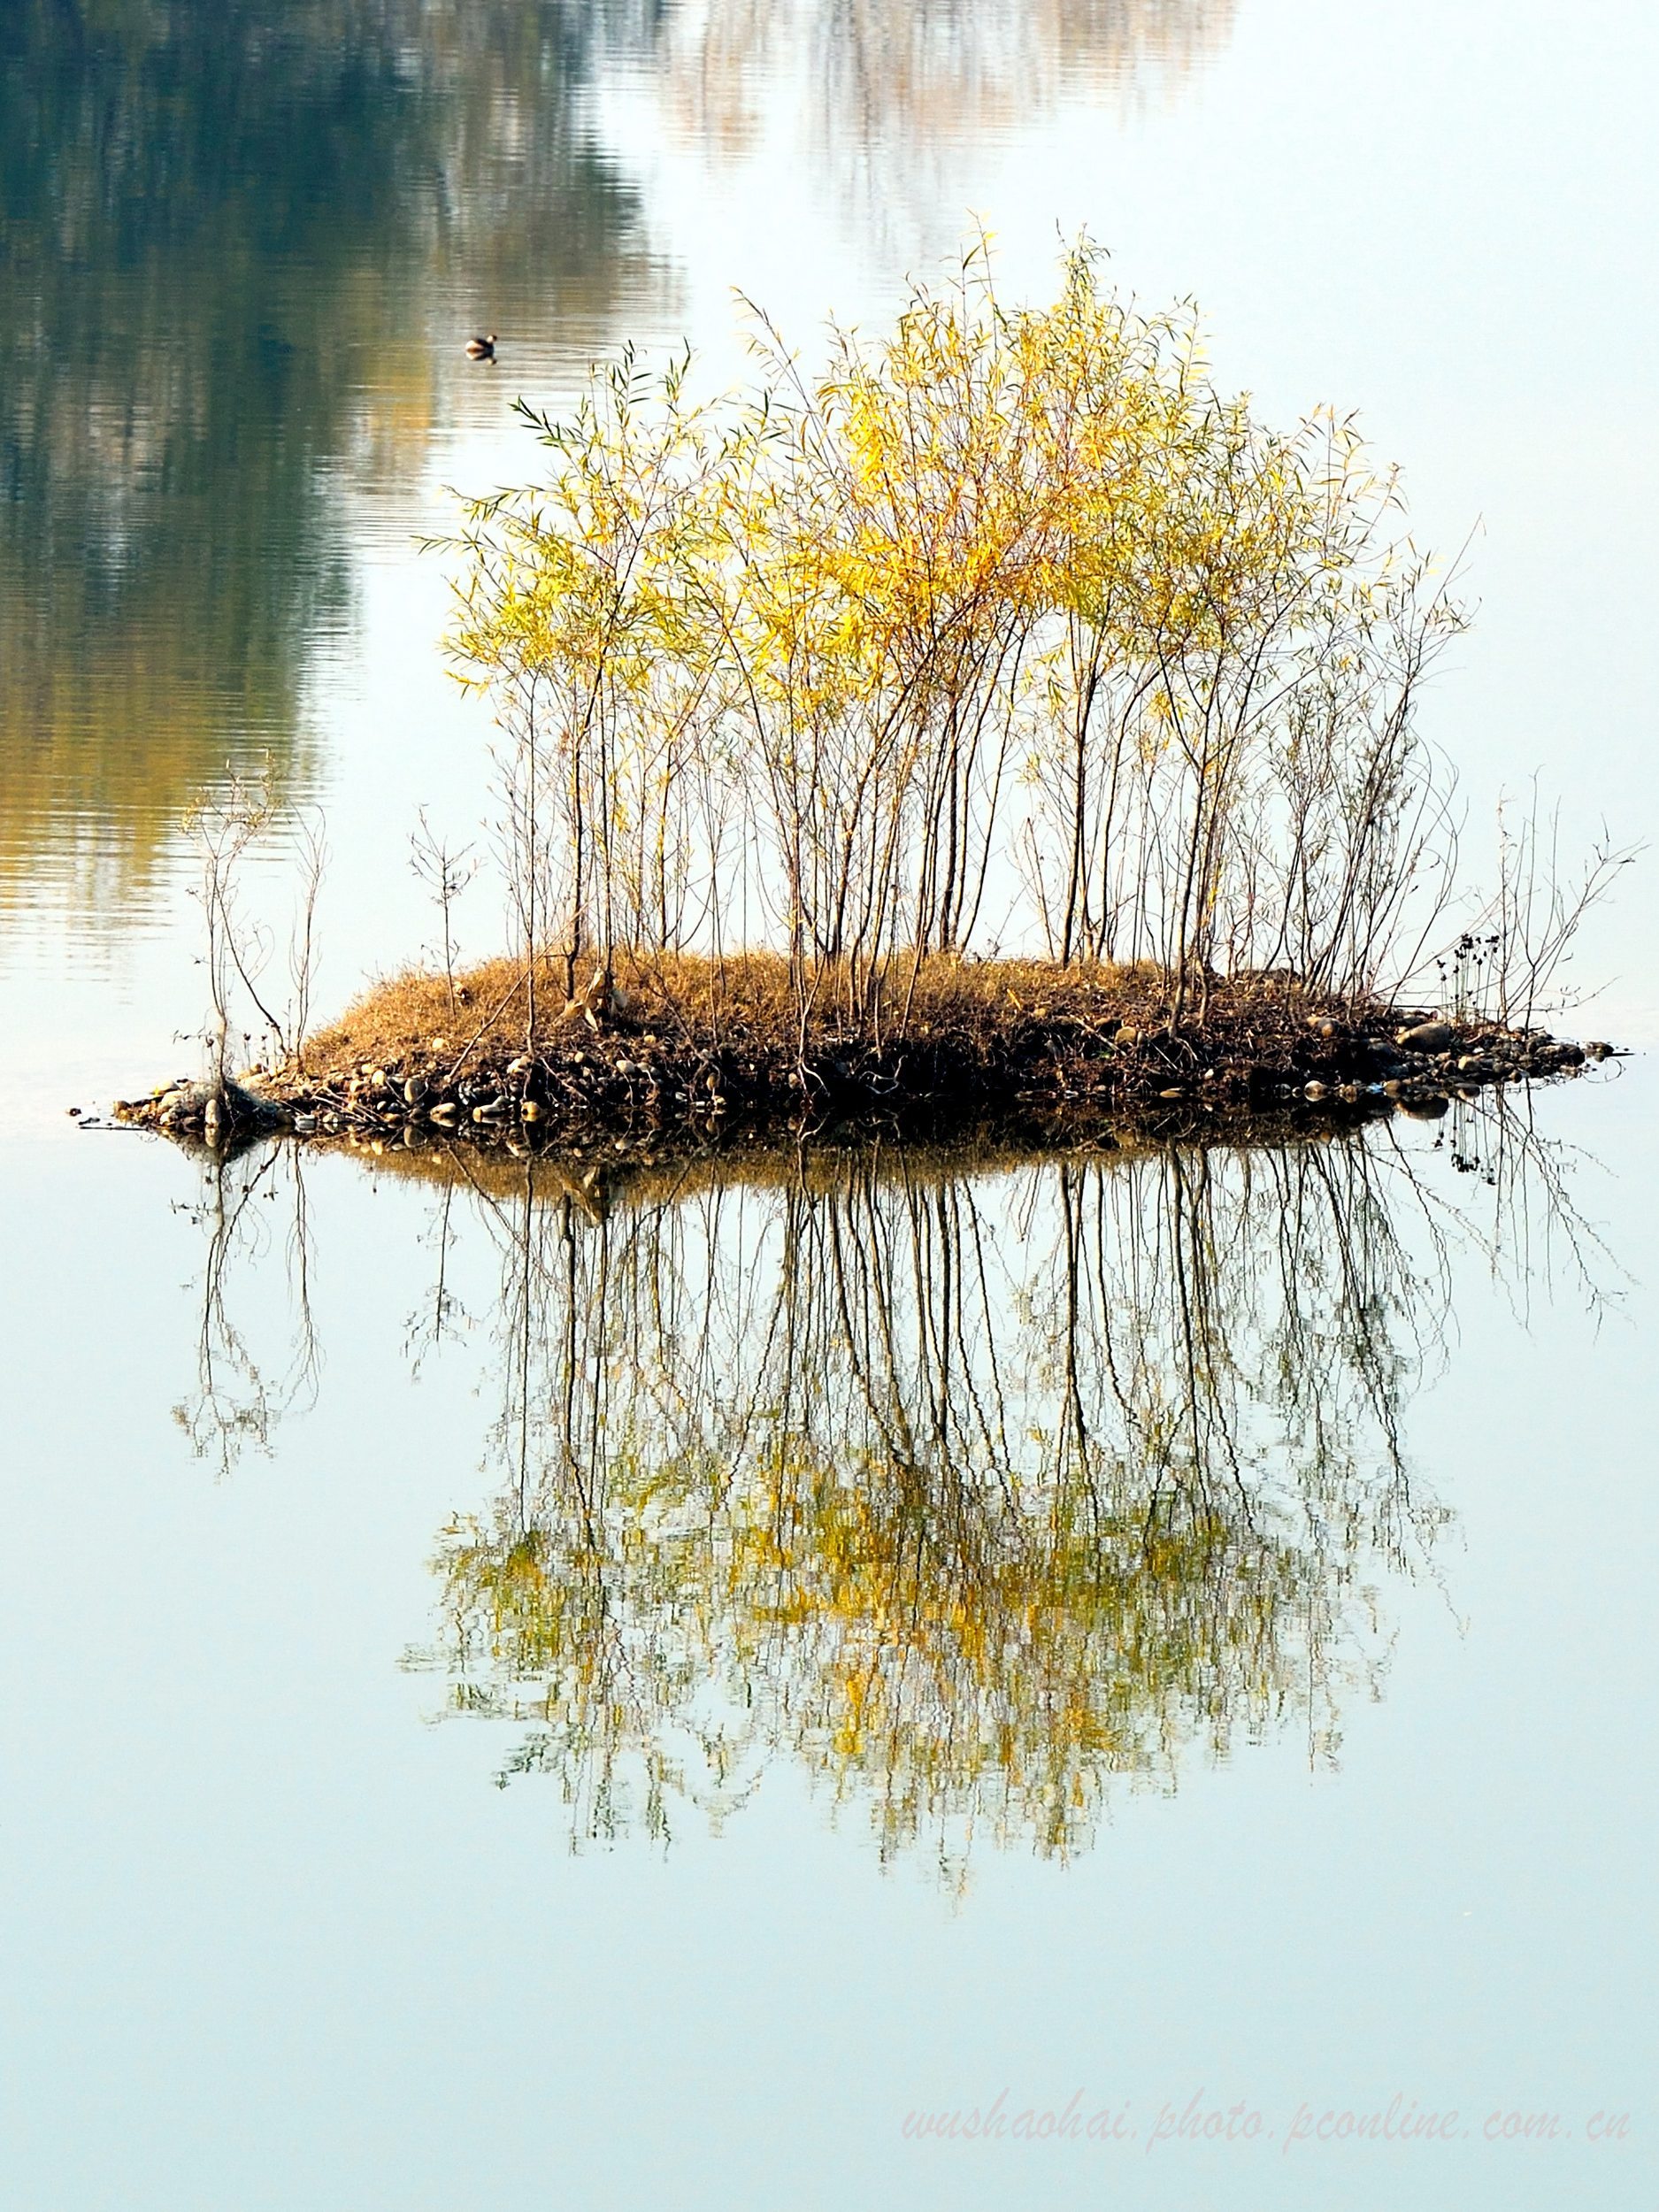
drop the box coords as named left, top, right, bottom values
left=0, top=0, right=659, bottom=918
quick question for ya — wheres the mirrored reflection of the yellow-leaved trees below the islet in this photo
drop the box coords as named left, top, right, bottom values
left=409, top=1144, right=1438, bottom=1854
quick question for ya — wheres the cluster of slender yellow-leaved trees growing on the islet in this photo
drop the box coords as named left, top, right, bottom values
left=454, top=243, right=1460, bottom=1018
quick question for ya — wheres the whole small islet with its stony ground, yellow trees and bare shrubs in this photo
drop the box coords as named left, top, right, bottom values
left=122, top=242, right=1628, bottom=1150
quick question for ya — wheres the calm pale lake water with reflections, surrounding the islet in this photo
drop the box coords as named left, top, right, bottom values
left=0, top=0, right=1659, bottom=2212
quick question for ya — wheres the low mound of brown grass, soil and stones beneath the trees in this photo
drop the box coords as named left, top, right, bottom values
left=118, top=956, right=1610, bottom=1157
